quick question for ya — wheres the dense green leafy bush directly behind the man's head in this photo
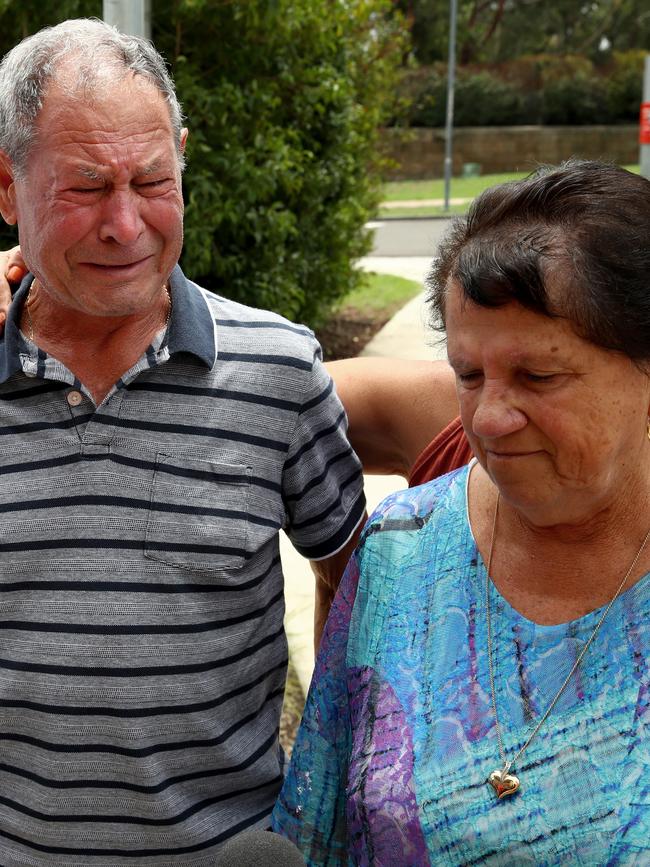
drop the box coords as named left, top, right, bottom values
left=0, top=0, right=407, bottom=325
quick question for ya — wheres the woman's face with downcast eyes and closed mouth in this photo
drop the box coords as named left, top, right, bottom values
left=446, top=282, right=650, bottom=526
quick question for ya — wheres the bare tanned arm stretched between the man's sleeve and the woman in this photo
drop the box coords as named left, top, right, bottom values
left=326, top=358, right=458, bottom=478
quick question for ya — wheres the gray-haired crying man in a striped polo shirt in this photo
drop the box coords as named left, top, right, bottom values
left=0, top=20, right=364, bottom=867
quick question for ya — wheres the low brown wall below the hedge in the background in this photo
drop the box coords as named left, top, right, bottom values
left=383, top=124, right=639, bottom=180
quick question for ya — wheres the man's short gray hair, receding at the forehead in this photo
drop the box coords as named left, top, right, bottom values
left=0, top=18, right=183, bottom=175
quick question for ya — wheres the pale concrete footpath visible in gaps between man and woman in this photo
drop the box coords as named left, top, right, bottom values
left=280, top=256, right=445, bottom=692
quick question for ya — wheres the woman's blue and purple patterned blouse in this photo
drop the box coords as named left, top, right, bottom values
left=274, top=467, right=650, bottom=867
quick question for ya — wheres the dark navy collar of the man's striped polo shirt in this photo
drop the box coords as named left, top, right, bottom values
left=0, top=265, right=217, bottom=383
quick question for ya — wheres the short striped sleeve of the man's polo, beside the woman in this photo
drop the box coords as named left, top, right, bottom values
left=282, top=340, right=365, bottom=560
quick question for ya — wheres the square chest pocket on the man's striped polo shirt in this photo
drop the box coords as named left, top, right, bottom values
left=144, top=452, right=251, bottom=572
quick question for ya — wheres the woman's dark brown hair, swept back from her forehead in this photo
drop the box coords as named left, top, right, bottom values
left=427, top=160, right=650, bottom=363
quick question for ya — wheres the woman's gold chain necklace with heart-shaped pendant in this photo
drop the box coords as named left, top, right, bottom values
left=485, top=493, right=650, bottom=798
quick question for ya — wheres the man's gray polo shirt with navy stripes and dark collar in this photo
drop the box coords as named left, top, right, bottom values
left=0, top=268, right=364, bottom=867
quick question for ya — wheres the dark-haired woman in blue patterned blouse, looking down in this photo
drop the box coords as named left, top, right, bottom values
left=274, top=161, right=650, bottom=867
